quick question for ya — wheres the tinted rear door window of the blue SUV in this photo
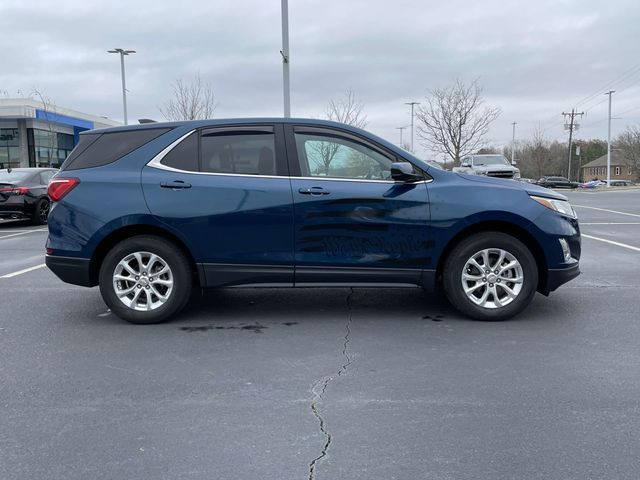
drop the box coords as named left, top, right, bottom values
left=200, top=132, right=276, bottom=175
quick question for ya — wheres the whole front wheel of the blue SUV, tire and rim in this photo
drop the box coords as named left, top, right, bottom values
left=443, top=232, right=538, bottom=320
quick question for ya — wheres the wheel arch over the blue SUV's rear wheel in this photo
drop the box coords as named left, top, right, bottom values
left=89, top=224, right=204, bottom=286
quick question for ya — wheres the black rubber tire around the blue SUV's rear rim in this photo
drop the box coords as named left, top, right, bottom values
left=99, top=235, right=192, bottom=325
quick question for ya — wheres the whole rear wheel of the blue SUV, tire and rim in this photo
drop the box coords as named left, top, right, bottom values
left=100, top=235, right=192, bottom=324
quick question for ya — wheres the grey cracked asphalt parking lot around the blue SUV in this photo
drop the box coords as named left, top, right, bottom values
left=0, top=189, right=640, bottom=480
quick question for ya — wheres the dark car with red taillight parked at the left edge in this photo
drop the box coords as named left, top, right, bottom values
left=0, top=168, right=57, bottom=225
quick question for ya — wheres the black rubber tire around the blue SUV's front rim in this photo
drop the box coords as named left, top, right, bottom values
left=443, top=232, right=538, bottom=321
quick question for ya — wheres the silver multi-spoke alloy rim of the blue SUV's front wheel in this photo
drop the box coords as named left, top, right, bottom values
left=461, top=248, right=524, bottom=308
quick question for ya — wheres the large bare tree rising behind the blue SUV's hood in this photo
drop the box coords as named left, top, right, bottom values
left=416, top=80, right=500, bottom=165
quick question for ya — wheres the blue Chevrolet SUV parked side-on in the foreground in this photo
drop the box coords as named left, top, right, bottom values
left=46, top=118, right=580, bottom=323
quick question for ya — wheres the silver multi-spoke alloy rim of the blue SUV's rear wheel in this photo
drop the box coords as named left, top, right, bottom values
left=113, top=252, right=173, bottom=311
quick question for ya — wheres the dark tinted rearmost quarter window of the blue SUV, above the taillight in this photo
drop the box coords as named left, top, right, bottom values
left=61, top=128, right=170, bottom=170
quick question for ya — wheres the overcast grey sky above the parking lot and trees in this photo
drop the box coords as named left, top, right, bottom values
left=0, top=0, right=640, bottom=156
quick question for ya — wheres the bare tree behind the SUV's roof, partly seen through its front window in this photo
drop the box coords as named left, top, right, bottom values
left=312, top=90, right=367, bottom=175
